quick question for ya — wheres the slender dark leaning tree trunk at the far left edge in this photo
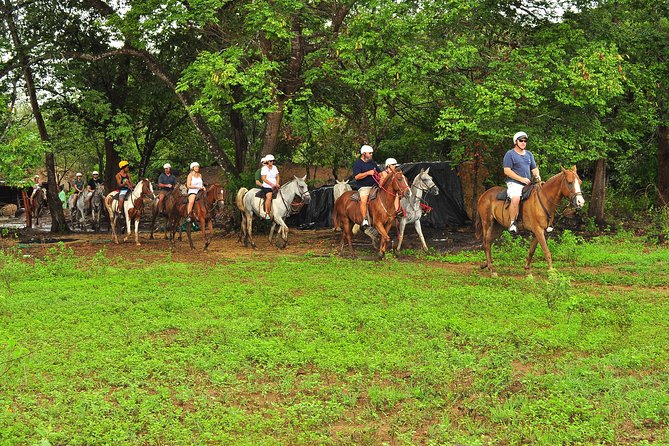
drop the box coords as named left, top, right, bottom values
left=3, top=1, right=70, bottom=233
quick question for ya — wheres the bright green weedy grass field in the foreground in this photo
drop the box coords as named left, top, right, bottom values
left=0, top=232, right=669, bottom=445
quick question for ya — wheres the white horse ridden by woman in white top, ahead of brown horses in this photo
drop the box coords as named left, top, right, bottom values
left=235, top=175, right=311, bottom=249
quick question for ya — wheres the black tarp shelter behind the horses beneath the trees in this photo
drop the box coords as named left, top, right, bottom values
left=287, top=162, right=468, bottom=229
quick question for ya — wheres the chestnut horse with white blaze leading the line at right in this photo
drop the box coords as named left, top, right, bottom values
left=475, top=166, right=585, bottom=275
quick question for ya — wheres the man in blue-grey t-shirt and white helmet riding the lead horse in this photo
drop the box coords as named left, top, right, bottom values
left=504, top=132, right=553, bottom=233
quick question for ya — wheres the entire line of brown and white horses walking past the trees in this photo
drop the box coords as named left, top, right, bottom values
left=26, top=166, right=585, bottom=275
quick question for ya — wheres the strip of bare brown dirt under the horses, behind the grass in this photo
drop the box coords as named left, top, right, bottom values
left=0, top=211, right=480, bottom=262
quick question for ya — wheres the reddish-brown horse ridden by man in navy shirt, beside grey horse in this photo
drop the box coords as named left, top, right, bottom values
left=333, top=170, right=410, bottom=258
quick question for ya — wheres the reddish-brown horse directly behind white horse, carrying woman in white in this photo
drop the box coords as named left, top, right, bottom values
left=170, top=183, right=224, bottom=251
